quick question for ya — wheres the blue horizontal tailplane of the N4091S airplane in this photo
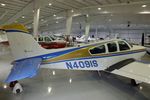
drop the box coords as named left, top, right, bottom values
left=5, top=58, right=42, bottom=83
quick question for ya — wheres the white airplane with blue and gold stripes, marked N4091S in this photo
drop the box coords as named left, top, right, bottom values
left=0, top=24, right=150, bottom=93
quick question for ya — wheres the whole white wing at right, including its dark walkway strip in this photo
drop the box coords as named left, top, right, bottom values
left=106, top=59, right=150, bottom=84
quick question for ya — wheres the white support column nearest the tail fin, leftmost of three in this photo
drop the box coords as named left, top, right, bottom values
left=33, top=0, right=40, bottom=38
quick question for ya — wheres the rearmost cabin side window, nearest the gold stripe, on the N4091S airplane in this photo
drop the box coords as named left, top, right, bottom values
left=90, top=45, right=106, bottom=54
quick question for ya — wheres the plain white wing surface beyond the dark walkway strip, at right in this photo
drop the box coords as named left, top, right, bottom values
left=111, top=62, right=150, bottom=84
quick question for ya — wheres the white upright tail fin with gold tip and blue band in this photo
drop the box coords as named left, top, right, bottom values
left=3, top=24, right=45, bottom=60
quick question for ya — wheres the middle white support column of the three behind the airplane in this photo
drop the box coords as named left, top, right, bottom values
left=66, top=11, right=72, bottom=36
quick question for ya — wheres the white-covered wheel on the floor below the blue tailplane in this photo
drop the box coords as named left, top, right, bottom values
left=9, top=81, right=23, bottom=94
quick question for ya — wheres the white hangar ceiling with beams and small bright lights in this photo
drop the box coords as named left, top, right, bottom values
left=0, top=0, right=150, bottom=30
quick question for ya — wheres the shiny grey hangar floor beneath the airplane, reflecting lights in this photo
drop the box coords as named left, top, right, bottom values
left=0, top=55, right=150, bottom=100
